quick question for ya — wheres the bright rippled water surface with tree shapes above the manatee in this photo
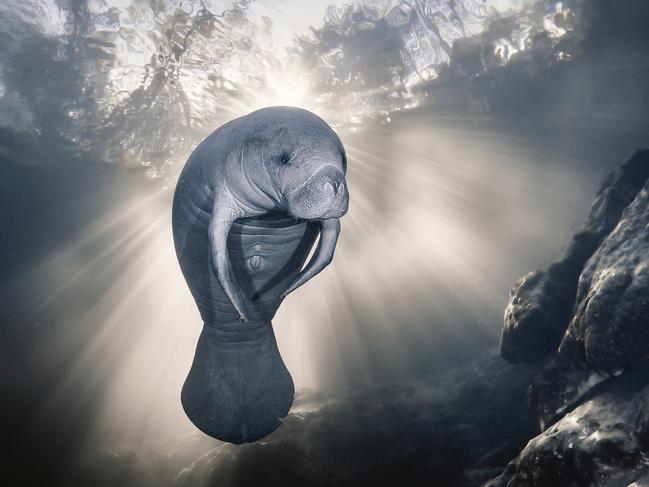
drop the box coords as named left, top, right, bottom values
left=0, top=0, right=570, bottom=182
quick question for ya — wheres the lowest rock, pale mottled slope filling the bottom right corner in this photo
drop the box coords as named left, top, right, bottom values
left=485, top=368, right=649, bottom=487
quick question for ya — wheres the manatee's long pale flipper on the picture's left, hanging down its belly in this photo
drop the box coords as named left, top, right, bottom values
left=208, top=191, right=248, bottom=321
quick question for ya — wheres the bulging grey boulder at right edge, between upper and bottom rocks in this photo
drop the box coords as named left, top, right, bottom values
left=559, top=183, right=649, bottom=374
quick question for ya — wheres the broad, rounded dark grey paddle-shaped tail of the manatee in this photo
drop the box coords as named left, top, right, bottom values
left=181, top=322, right=295, bottom=444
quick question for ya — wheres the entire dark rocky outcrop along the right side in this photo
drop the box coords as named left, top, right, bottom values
left=488, top=151, right=649, bottom=487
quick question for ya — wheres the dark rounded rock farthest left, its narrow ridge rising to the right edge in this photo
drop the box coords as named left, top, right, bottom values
left=500, top=150, right=649, bottom=363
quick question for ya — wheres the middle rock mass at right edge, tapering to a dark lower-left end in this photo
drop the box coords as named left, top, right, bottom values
left=530, top=174, right=649, bottom=424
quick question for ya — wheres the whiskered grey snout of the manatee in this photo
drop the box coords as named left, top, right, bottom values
left=287, top=165, right=349, bottom=220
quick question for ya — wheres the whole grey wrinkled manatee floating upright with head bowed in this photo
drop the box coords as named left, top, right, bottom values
left=173, top=107, right=349, bottom=443
